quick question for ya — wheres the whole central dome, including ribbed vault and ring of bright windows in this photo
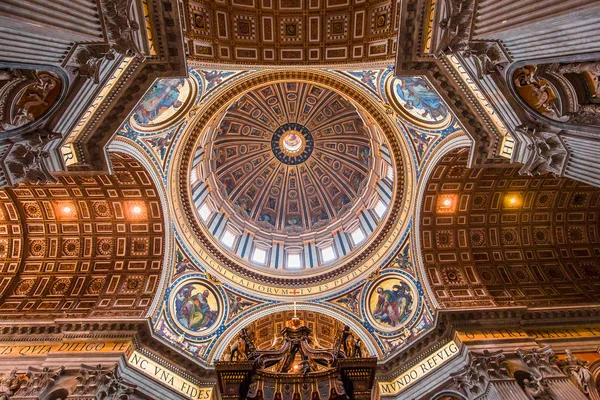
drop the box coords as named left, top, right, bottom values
left=190, top=80, right=395, bottom=276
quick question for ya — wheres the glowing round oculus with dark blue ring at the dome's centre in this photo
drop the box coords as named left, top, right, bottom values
left=271, top=123, right=315, bottom=165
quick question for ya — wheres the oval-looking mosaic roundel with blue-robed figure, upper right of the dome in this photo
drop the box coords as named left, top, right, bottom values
left=392, top=77, right=449, bottom=123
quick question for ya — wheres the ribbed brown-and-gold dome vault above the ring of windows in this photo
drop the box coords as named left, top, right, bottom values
left=211, top=82, right=375, bottom=234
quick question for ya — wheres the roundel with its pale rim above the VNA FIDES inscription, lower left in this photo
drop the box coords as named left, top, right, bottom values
left=169, top=280, right=223, bottom=336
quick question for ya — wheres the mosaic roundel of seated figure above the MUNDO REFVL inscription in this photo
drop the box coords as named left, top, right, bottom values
left=368, top=278, right=418, bottom=330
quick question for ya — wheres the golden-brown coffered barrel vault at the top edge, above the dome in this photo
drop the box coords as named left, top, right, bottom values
left=184, top=0, right=400, bottom=64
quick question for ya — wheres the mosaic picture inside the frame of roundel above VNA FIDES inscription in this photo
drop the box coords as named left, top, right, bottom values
left=174, top=283, right=220, bottom=333
